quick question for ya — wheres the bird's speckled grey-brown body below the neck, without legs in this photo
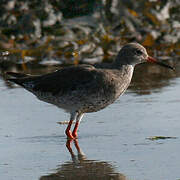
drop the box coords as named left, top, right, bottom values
left=8, top=65, right=133, bottom=113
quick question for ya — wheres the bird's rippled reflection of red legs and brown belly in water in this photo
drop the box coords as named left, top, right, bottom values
left=40, top=139, right=127, bottom=180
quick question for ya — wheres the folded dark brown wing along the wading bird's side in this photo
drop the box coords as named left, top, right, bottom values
left=14, top=65, right=95, bottom=95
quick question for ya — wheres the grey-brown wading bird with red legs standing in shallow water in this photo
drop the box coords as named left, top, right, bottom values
left=7, top=42, right=173, bottom=139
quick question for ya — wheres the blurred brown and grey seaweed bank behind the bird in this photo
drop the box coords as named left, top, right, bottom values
left=0, top=0, right=180, bottom=71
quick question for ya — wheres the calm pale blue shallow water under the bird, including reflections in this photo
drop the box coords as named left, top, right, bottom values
left=0, top=60, right=180, bottom=180
